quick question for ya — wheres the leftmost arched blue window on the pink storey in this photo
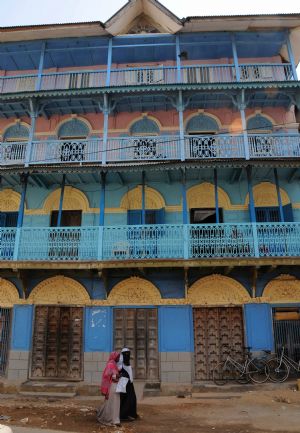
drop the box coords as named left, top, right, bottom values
left=3, top=122, right=29, bottom=163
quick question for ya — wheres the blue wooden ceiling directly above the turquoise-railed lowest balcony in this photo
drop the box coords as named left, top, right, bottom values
left=1, top=166, right=300, bottom=188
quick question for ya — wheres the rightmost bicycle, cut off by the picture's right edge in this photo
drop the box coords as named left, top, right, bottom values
left=267, top=346, right=300, bottom=382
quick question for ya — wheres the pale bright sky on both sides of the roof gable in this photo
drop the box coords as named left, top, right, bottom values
left=0, top=0, right=300, bottom=26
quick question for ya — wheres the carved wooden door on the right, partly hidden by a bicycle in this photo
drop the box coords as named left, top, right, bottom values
left=193, top=307, right=244, bottom=380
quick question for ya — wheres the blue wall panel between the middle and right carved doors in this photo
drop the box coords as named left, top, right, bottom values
left=158, top=306, right=194, bottom=352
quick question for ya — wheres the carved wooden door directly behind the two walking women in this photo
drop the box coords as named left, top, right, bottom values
left=114, top=308, right=159, bottom=381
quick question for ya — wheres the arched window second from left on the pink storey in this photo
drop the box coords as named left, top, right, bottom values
left=57, top=119, right=90, bottom=162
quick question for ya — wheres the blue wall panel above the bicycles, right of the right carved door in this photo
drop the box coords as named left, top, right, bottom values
left=244, top=304, right=274, bottom=351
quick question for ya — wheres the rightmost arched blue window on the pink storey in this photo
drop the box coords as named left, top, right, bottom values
left=247, top=114, right=274, bottom=158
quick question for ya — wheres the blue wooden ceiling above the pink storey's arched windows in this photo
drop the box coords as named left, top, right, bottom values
left=0, top=82, right=300, bottom=118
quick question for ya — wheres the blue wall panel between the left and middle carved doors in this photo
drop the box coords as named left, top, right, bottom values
left=84, top=307, right=113, bottom=352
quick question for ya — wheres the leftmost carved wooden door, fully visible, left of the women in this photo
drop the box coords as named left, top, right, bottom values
left=31, top=306, right=83, bottom=380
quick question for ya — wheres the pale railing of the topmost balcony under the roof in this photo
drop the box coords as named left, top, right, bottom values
left=0, top=63, right=294, bottom=93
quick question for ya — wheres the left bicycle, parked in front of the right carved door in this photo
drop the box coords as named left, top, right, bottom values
left=213, top=347, right=269, bottom=386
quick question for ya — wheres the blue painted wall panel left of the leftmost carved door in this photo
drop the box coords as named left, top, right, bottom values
left=11, top=305, right=33, bottom=351
